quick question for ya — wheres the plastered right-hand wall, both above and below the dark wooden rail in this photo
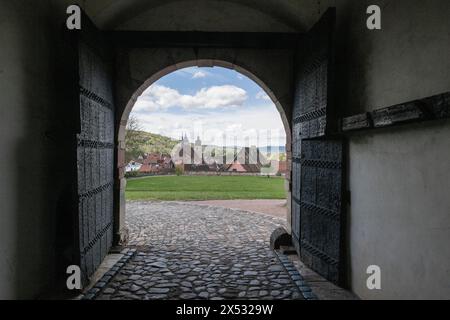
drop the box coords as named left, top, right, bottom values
left=346, top=0, right=450, bottom=299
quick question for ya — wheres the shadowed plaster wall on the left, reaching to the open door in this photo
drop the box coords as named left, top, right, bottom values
left=0, top=0, right=75, bottom=299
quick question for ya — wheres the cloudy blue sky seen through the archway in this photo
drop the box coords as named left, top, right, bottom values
left=131, top=67, right=285, bottom=146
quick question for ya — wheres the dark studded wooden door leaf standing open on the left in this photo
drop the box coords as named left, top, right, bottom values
left=74, top=11, right=114, bottom=283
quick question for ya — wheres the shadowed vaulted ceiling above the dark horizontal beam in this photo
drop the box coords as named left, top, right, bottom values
left=74, top=0, right=345, bottom=32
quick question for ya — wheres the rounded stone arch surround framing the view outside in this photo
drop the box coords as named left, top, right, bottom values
left=115, top=59, right=292, bottom=240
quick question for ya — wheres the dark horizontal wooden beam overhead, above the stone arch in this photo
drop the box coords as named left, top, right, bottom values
left=105, top=31, right=302, bottom=49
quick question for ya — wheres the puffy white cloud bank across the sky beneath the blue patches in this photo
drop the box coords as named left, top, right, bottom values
left=133, top=85, right=248, bottom=112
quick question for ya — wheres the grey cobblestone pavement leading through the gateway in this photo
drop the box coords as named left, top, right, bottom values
left=98, top=202, right=301, bottom=300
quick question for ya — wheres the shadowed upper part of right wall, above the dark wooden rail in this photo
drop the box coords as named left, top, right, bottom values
left=338, top=0, right=450, bottom=114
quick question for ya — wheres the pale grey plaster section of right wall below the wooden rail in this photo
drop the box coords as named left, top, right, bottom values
left=350, top=121, right=450, bottom=299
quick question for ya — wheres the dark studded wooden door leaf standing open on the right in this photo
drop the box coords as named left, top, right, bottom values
left=292, top=9, right=343, bottom=283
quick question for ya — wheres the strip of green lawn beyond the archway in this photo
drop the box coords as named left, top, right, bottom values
left=126, top=176, right=286, bottom=200
